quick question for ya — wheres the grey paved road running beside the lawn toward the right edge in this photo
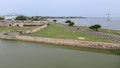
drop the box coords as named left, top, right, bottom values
left=52, top=24, right=120, bottom=43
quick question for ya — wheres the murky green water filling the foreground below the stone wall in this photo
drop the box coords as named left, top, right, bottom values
left=0, top=40, right=120, bottom=68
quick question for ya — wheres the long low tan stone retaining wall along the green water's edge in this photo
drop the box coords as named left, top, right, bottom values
left=16, top=35, right=120, bottom=49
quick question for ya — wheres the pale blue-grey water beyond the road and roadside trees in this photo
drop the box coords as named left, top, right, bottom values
left=49, top=17, right=120, bottom=30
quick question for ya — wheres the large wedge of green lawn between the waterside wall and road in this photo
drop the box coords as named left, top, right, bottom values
left=28, top=25, right=113, bottom=43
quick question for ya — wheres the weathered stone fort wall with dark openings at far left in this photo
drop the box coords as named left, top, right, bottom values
left=0, top=20, right=48, bottom=27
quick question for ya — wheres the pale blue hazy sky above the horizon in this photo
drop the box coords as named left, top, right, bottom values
left=0, top=0, right=120, bottom=17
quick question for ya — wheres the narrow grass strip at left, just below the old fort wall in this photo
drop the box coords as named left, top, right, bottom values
left=0, top=27, right=36, bottom=32
